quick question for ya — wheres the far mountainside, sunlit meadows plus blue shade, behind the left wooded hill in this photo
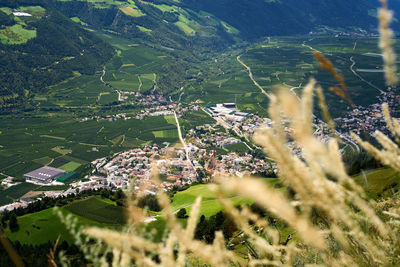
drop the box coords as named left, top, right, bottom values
left=53, top=0, right=400, bottom=43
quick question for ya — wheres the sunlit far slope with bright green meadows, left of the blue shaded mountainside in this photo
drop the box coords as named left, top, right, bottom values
left=53, top=0, right=238, bottom=49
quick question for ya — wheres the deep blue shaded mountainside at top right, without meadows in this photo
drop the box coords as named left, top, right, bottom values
left=182, top=0, right=376, bottom=39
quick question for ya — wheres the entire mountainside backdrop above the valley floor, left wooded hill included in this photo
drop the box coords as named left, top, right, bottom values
left=0, top=0, right=399, bottom=108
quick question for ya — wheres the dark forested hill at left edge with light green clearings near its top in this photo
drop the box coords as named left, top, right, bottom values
left=0, top=0, right=114, bottom=108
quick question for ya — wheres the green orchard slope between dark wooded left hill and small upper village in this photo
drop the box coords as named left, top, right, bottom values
left=34, top=33, right=177, bottom=108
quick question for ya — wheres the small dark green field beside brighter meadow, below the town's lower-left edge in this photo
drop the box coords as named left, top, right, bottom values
left=65, top=197, right=125, bottom=225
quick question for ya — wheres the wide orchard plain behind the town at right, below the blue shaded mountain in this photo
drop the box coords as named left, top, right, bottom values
left=182, top=36, right=399, bottom=115
